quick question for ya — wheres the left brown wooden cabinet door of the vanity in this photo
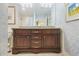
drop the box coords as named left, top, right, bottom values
left=14, top=36, right=30, bottom=48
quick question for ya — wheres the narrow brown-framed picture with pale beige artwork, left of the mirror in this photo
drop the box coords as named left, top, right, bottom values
left=8, top=6, right=16, bottom=25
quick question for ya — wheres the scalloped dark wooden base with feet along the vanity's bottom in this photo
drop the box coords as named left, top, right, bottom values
left=12, top=48, right=62, bottom=54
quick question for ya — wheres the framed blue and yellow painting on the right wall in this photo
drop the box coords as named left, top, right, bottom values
left=65, top=3, right=79, bottom=22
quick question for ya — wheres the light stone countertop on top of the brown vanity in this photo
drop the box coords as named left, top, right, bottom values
left=13, top=26, right=59, bottom=29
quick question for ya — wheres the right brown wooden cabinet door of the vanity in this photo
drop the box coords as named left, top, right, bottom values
left=44, top=35, right=58, bottom=48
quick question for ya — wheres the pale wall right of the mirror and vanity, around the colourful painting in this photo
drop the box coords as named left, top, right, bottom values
left=56, top=4, right=79, bottom=55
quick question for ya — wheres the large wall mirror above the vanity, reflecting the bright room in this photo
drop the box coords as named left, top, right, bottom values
left=20, top=3, right=55, bottom=26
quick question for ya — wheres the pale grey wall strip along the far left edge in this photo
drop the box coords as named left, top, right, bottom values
left=0, top=3, right=8, bottom=55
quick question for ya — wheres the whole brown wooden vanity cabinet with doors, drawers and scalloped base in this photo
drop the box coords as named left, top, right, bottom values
left=12, top=28, right=61, bottom=54
